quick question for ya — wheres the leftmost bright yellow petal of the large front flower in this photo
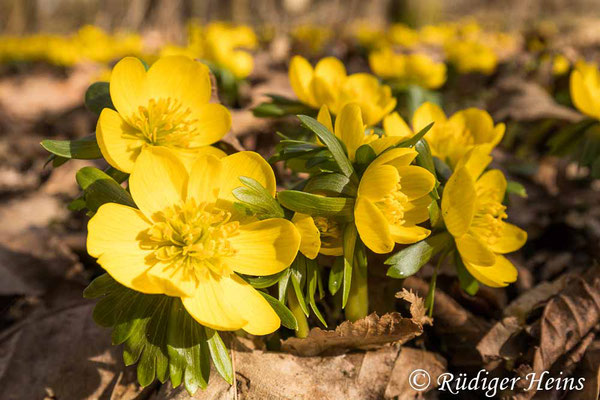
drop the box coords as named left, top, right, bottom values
left=87, top=203, right=162, bottom=293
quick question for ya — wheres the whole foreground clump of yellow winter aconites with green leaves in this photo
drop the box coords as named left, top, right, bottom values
left=42, top=50, right=528, bottom=393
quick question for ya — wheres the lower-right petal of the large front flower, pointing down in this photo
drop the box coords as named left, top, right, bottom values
left=222, top=274, right=280, bottom=335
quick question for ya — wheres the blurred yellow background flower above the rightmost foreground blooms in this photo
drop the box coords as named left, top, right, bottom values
left=445, top=40, right=498, bottom=75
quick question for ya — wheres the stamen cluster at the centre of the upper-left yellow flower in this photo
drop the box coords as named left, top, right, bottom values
left=129, top=97, right=197, bottom=148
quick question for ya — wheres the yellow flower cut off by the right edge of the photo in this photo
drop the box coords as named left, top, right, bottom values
left=570, top=61, right=600, bottom=119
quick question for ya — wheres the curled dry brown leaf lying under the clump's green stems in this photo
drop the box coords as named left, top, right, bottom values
left=281, top=291, right=431, bottom=356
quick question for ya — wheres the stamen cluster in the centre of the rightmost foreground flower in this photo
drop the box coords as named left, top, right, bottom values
left=471, top=188, right=508, bottom=244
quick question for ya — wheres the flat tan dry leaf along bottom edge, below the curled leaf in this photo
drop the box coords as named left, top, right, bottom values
left=152, top=346, right=446, bottom=400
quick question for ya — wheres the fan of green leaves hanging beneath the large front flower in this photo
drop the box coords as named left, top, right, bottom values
left=84, top=274, right=233, bottom=395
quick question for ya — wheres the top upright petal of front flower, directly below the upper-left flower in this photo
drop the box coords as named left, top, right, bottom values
left=129, top=146, right=188, bottom=218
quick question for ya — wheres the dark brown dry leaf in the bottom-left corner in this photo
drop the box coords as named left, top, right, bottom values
left=0, top=303, right=132, bottom=399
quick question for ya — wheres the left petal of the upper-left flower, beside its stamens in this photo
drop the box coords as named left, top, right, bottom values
left=96, top=108, right=146, bottom=173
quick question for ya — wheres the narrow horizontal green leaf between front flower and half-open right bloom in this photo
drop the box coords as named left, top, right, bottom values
left=277, top=190, right=354, bottom=219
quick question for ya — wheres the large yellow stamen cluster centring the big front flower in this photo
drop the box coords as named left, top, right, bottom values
left=144, top=200, right=239, bottom=279
